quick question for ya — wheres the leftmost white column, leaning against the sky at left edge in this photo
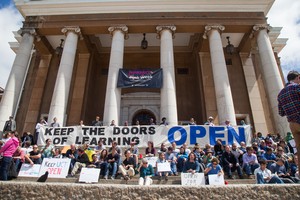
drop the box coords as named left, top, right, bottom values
left=0, top=28, right=36, bottom=131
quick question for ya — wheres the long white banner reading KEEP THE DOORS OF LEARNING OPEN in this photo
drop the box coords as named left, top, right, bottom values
left=38, top=125, right=251, bottom=147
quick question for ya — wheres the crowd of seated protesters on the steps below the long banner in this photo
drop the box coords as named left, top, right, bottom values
left=1, top=130, right=300, bottom=185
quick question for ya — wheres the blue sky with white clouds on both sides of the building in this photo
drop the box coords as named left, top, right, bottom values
left=0, top=0, right=300, bottom=88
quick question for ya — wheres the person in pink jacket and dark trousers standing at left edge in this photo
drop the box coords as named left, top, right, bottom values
left=0, top=132, right=19, bottom=181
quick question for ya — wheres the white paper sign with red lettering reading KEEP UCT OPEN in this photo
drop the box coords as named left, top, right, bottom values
left=39, top=158, right=71, bottom=178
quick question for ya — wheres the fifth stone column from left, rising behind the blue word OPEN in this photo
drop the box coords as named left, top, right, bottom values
left=203, top=26, right=236, bottom=125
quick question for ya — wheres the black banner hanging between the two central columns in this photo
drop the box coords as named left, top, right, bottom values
left=117, top=69, right=163, bottom=88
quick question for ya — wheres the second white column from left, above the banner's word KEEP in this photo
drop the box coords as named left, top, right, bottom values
left=48, top=27, right=80, bottom=126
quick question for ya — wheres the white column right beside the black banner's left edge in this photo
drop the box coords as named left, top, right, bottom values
left=103, top=26, right=128, bottom=126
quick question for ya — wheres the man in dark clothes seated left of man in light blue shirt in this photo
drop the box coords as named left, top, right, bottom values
left=222, top=145, right=243, bottom=179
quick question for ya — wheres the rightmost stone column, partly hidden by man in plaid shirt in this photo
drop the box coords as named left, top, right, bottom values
left=253, top=25, right=290, bottom=135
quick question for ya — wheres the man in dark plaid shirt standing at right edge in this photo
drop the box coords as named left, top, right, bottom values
left=277, top=71, right=300, bottom=167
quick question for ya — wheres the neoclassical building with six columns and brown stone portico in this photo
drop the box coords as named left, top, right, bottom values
left=0, top=0, right=288, bottom=135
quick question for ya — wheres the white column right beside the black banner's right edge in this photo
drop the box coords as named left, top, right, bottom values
left=156, top=26, right=178, bottom=125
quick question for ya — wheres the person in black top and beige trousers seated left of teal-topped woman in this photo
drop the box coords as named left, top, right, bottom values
left=119, top=150, right=136, bottom=180
